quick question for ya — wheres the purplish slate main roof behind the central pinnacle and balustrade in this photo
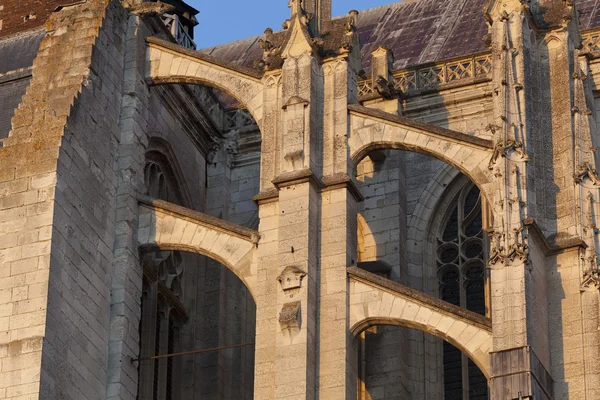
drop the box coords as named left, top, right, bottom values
left=202, top=0, right=600, bottom=71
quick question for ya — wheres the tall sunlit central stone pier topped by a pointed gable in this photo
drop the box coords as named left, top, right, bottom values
left=255, top=14, right=322, bottom=399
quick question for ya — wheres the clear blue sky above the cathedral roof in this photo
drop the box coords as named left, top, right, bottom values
left=187, top=0, right=394, bottom=49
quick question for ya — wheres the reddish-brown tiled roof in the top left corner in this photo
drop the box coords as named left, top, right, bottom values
left=0, top=0, right=65, bottom=39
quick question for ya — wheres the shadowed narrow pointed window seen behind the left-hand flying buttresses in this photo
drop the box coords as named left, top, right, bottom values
left=138, top=156, right=188, bottom=400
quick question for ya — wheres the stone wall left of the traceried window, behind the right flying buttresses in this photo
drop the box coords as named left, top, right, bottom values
left=357, top=73, right=493, bottom=400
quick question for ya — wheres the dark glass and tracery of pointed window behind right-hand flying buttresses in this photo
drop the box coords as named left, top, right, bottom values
left=436, top=183, right=488, bottom=400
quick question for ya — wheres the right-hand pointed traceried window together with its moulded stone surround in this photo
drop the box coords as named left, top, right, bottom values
left=422, top=174, right=490, bottom=399
